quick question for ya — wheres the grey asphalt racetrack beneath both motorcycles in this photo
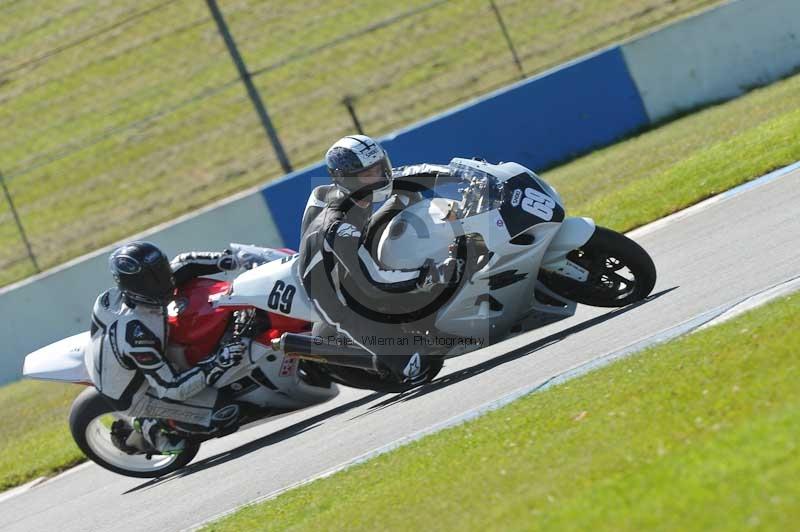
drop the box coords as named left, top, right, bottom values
left=0, top=170, right=800, bottom=532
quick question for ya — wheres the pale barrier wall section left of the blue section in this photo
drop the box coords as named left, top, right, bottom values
left=0, top=187, right=283, bottom=384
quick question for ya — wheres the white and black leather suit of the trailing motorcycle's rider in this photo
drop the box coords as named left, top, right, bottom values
left=87, top=252, right=250, bottom=434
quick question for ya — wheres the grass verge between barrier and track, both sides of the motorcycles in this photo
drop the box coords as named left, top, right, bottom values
left=0, top=68, right=800, bottom=489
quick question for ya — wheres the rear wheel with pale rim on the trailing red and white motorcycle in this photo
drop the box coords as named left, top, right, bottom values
left=69, top=387, right=200, bottom=478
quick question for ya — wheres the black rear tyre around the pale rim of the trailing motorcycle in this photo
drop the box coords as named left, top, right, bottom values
left=69, top=387, right=200, bottom=478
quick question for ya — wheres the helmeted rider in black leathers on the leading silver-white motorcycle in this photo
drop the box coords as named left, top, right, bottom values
left=300, top=135, right=463, bottom=385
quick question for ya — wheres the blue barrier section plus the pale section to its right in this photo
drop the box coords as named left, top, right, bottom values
left=263, top=0, right=800, bottom=247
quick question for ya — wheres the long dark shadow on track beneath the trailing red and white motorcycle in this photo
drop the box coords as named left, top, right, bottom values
left=123, top=392, right=385, bottom=495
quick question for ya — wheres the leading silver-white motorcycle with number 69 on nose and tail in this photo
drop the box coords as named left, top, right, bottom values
left=217, top=158, right=656, bottom=384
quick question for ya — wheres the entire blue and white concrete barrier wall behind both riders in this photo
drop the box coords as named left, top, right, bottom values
left=0, top=0, right=800, bottom=384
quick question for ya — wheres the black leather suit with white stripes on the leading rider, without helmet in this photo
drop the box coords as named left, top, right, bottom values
left=299, top=164, right=456, bottom=383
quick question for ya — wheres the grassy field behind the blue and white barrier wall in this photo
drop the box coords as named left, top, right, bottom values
left=0, top=0, right=719, bottom=285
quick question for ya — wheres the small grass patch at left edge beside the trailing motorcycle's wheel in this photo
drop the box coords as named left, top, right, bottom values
left=0, top=381, right=85, bottom=490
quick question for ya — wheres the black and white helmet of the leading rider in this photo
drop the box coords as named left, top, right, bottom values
left=325, top=135, right=392, bottom=202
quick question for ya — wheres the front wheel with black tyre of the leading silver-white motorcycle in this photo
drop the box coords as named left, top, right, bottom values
left=539, top=226, right=656, bottom=307
